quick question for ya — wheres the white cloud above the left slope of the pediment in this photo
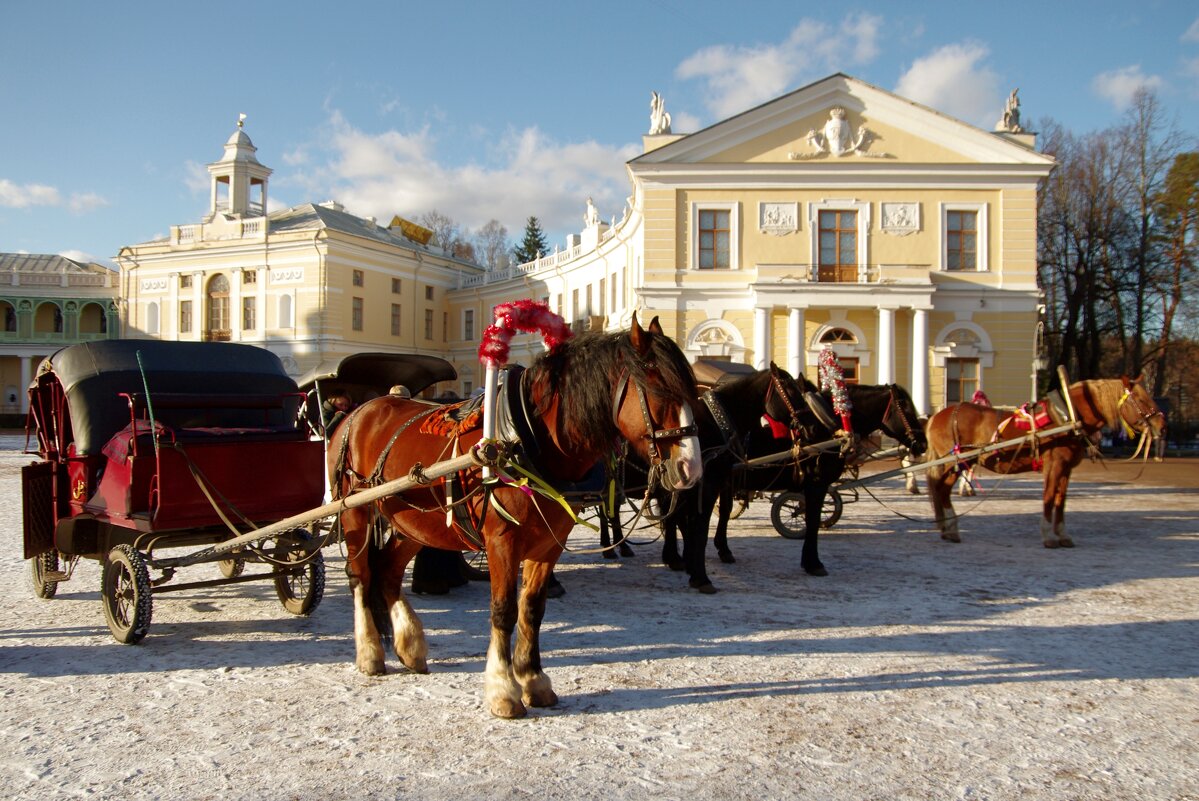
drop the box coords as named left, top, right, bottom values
left=675, top=13, right=882, bottom=119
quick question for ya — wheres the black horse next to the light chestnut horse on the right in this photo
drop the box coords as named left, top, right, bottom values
left=700, top=377, right=928, bottom=576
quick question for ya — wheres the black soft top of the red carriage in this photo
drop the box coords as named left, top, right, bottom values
left=37, top=339, right=301, bottom=454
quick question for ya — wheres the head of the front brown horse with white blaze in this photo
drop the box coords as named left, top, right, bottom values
left=613, top=312, right=704, bottom=492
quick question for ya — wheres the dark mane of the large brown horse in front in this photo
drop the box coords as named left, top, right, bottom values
left=526, top=331, right=697, bottom=451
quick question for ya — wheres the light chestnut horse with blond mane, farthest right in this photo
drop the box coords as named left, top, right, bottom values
left=926, top=378, right=1165, bottom=548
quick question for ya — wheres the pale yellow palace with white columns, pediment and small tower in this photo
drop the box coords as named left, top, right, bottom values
left=120, top=74, right=1054, bottom=411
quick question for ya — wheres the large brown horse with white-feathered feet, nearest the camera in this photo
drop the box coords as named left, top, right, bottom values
left=329, top=317, right=703, bottom=718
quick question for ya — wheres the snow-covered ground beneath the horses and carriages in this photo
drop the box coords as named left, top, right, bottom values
left=0, top=436, right=1199, bottom=801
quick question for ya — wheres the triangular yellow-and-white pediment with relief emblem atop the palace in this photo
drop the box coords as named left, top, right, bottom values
left=631, top=74, right=1053, bottom=167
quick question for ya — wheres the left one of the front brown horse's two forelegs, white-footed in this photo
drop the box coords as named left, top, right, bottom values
left=483, top=544, right=529, bottom=718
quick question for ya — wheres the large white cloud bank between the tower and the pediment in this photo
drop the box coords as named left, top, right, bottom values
left=287, top=112, right=639, bottom=246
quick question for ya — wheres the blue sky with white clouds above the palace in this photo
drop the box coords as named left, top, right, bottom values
left=0, top=0, right=1199, bottom=268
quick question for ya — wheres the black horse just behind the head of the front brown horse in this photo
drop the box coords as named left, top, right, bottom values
left=662, top=363, right=831, bottom=594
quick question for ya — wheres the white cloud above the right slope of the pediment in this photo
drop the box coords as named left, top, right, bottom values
left=896, top=43, right=1006, bottom=128
